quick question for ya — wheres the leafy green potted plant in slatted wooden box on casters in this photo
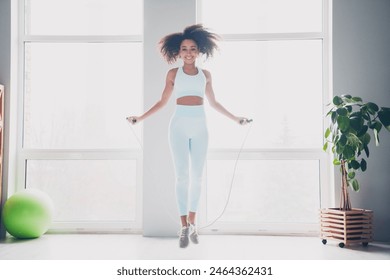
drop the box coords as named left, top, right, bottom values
left=321, top=95, right=390, bottom=247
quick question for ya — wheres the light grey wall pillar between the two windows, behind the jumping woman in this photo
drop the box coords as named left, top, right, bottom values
left=142, top=0, right=196, bottom=236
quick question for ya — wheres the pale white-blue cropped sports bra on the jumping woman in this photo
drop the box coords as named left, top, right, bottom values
left=174, top=67, right=206, bottom=99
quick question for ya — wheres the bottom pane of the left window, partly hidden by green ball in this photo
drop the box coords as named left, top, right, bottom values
left=26, top=160, right=136, bottom=222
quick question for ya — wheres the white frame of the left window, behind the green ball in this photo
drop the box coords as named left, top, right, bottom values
left=15, top=0, right=143, bottom=233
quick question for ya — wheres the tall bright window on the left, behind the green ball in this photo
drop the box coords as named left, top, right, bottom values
left=18, top=0, right=143, bottom=231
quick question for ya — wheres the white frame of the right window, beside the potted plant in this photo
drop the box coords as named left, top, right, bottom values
left=197, top=0, right=335, bottom=235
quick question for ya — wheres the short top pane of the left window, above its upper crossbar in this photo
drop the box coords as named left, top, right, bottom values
left=25, top=0, right=143, bottom=35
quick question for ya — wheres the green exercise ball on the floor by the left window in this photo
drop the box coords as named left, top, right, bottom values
left=2, top=189, right=53, bottom=239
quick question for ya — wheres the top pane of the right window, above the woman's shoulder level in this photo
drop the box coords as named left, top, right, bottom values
left=201, top=0, right=322, bottom=34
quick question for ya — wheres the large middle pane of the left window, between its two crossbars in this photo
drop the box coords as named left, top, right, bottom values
left=24, top=43, right=143, bottom=149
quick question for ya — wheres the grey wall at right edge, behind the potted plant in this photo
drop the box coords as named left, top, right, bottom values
left=333, top=0, right=390, bottom=241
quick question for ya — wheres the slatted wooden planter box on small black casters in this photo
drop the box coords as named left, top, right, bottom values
left=320, top=208, right=373, bottom=248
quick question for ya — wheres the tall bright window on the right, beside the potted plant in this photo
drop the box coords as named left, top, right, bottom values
left=198, top=0, right=330, bottom=234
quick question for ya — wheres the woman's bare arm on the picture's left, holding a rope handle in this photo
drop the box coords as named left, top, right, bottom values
left=127, top=68, right=177, bottom=124
